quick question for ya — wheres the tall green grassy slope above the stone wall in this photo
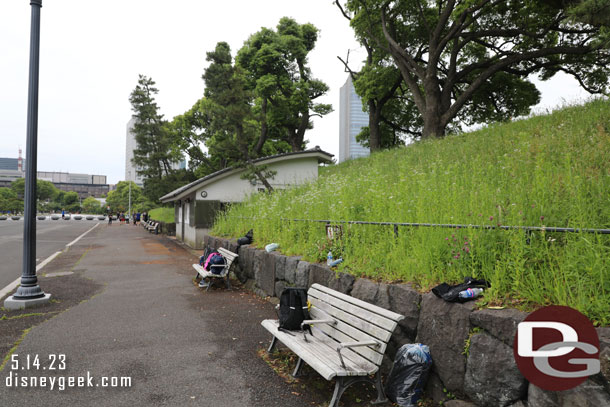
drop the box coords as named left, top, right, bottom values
left=214, top=101, right=610, bottom=325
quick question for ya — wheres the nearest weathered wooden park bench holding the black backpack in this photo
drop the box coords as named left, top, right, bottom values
left=261, top=284, right=404, bottom=407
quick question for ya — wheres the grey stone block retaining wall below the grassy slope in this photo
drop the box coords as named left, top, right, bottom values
left=205, top=236, right=610, bottom=407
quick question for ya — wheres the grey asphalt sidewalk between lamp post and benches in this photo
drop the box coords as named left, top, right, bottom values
left=0, top=224, right=318, bottom=407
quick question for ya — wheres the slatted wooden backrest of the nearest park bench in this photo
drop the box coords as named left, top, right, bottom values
left=307, top=284, right=404, bottom=366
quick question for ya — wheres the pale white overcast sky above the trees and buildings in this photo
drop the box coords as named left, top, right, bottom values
left=0, top=0, right=587, bottom=184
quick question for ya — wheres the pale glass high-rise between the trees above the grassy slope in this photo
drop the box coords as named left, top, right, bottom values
left=339, top=76, right=370, bottom=162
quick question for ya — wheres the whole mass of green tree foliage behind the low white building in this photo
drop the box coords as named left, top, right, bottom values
left=168, top=18, right=332, bottom=188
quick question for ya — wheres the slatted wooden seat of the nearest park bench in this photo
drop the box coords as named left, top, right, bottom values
left=261, top=319, right=379, bottom=380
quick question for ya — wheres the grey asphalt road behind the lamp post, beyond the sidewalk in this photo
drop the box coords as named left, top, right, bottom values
left=0, top=217, right=105, bottom=290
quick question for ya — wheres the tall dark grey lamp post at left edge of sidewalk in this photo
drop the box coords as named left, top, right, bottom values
left=4, top=0, right=51, bottom=309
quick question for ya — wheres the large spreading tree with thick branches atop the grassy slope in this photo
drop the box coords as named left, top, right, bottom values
left=345, top=0, right=610, bottom=138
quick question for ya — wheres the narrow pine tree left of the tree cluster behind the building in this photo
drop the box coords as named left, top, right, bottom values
left=129, top=75, right=182, bottom=201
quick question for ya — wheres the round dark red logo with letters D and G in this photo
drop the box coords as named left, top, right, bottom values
left=513, top=305, right=600, bottom=391
